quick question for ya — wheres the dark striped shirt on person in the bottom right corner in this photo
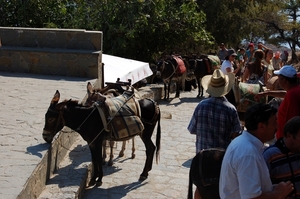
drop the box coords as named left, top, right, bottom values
left=263, top=138, right=300, bottom=199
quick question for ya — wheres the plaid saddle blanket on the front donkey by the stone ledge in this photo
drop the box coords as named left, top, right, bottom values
left=98, top=95, right=144, bottom=140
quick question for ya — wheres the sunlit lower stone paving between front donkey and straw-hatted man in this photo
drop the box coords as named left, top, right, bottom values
left=82, top=91, right=205, bottom=199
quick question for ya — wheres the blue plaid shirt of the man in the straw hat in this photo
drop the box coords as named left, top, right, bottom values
left=188, top=97, right=241, bottom=153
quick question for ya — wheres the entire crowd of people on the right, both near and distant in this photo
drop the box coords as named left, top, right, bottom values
left=187, top=42, right=300, bottom=199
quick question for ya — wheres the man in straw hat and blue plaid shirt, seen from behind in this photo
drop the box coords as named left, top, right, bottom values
left=188, top=69, right=241, bottom=199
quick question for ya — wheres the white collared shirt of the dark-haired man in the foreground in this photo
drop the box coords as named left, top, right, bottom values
left=219, top=131, right=273, bottom=199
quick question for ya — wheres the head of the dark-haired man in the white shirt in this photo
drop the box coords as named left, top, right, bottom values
left=245, top=103, right=277, bottom=142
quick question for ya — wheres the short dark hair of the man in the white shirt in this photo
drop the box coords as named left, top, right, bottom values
left=245, top=103, right=277, bottom=131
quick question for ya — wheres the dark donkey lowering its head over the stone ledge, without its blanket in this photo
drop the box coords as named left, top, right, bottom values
left=43, top=90, right=161, bottom=186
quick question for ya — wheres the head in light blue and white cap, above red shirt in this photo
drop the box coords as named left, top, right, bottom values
left=274, top=65, right=297, bottom=88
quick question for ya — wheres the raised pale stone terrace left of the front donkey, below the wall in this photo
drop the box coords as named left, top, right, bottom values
left=0, top=72, right=95, bottom=199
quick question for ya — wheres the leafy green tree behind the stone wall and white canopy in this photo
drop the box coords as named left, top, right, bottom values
left=65, top=0, right=213, bottom=61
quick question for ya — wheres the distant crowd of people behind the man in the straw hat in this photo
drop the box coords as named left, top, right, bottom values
left=218, top=42, right=289, bottom=84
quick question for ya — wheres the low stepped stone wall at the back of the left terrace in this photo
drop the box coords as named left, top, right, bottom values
left=0, top=27, right=102, bottom=78
